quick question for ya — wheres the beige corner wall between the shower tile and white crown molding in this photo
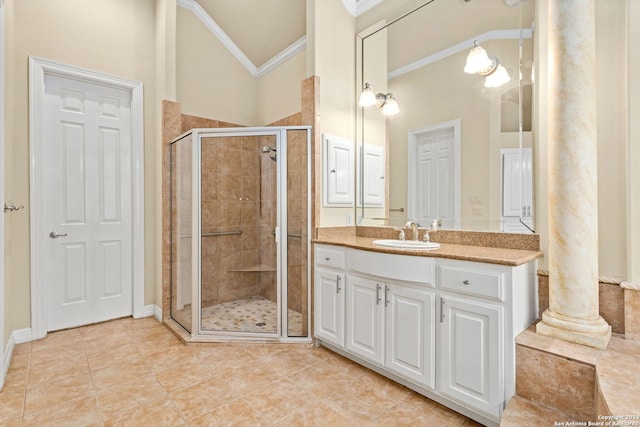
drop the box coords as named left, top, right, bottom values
left=175, top=7, right=306, bottom=126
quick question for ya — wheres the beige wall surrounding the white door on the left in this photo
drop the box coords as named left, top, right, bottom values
left=3, top=0, right=160, bottom=345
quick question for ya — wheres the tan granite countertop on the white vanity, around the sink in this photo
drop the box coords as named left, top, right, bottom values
left=312, top=235, right=543, bottom=266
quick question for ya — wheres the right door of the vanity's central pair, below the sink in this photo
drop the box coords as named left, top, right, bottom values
left=385, top=285, right=435, bottom=388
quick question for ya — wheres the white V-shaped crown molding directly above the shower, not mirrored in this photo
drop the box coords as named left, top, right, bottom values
left=178, top=0, right=308, bottom=78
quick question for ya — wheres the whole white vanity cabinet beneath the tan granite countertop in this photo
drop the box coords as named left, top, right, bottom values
left=315, top=245, right=537, bottom=425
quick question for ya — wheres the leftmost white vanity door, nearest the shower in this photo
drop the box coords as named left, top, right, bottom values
left=315, top=268, right=345, bottom=347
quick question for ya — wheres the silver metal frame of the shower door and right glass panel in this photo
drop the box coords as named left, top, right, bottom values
left=186, top=126, right=311, bottom=342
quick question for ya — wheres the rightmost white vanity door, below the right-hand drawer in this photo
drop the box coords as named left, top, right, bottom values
left=438, top=296, right=504, bottom=417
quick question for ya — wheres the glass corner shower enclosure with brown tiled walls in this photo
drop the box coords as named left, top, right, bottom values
left=171, top=126, right=311, bottom=341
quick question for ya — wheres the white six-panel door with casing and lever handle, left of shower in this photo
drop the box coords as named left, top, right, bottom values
left=30, top=58, right=144, bottom=339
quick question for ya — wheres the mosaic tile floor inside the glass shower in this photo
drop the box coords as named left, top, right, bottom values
left=174, top=296, right=302, bottom=336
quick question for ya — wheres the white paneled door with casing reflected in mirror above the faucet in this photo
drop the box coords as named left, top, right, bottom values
left=407, top=119, right=461, bottom=228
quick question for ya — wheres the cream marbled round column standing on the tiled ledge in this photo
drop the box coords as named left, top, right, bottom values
left=537, top=0, right=611, bottom=348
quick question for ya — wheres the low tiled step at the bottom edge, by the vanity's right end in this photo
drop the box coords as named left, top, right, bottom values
left=500, top=396, right=571, bottom=427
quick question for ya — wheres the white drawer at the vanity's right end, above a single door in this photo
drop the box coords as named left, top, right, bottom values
left=436, top=264, right=504, bottom=301
